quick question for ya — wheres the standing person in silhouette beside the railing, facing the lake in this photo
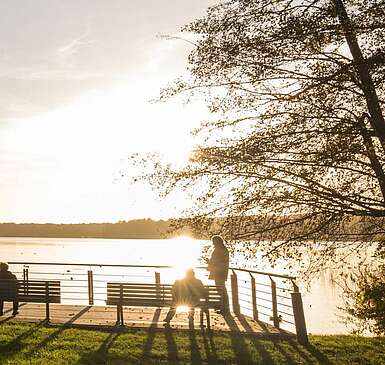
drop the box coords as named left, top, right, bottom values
left=207, top=235, right=230, bottom=314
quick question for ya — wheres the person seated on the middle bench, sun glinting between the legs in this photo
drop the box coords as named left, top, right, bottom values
left=164, top=269, right=206, bottom=325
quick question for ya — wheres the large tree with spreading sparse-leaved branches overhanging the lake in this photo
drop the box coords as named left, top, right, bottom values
left=134, top=0, right=385, bottom=272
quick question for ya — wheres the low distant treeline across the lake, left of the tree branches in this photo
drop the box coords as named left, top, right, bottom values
left=0, top=219, right=188, bottom=239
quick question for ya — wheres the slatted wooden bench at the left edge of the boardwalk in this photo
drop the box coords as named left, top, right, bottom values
left=0, top=279, right=60, bottom=321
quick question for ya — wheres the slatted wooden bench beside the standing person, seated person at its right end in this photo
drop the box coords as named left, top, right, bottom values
left=107, top=283, right=223, bottom=328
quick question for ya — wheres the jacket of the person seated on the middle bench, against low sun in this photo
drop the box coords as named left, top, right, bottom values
left=171, top=277, right=206, bottom=305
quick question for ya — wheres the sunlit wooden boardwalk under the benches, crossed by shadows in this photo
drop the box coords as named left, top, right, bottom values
left=0, top=303, right=295, bottom=337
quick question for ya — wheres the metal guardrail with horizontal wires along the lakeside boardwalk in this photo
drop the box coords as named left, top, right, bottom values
left=8, top=262, right=308, bottom=343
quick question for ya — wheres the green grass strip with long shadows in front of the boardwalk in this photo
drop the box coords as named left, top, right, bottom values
left=0, top=322, right=385, bottom=365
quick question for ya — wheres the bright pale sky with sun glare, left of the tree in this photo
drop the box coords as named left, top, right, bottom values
left=0, top=0, right=218, bottom=223
